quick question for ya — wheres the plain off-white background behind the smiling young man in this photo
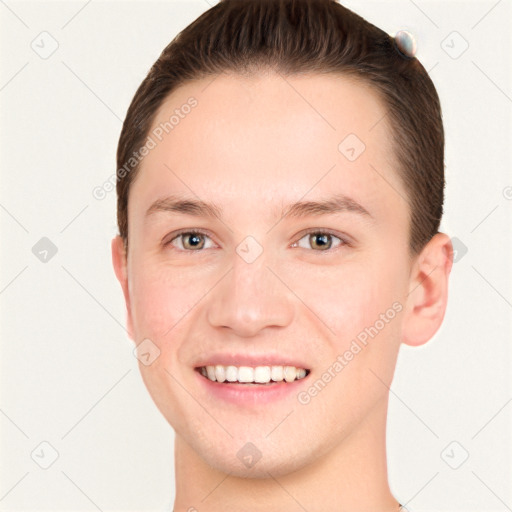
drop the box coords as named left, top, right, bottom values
left=0, top=0, right=512, bottom=512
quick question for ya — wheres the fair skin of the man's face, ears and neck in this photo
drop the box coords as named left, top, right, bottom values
left=112, top=72, right=452, bottom=512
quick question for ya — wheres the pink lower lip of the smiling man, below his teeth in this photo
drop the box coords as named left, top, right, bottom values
left=194, top=371, right=311, bottom=405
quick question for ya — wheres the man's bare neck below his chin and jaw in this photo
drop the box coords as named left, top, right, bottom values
left=170, top=398, right=399, bottom=512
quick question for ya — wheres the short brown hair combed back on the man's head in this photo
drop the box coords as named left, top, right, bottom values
left=116, top=0, right=445, bottom=255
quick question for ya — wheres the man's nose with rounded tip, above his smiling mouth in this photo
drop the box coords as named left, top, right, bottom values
left=208, top=254, right=295, bottom=337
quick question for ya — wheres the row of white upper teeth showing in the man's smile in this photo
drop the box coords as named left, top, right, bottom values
left=201, top=364, right=306, bottom=384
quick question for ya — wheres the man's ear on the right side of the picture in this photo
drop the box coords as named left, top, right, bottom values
left=402, top=233, right=453, bottom=346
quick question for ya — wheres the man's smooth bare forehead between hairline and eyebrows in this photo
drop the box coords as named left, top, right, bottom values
left=129, top=72, right=405, bottom=228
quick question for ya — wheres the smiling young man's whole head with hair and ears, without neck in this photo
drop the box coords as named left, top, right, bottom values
left=112, top=0, right=451, bottom=476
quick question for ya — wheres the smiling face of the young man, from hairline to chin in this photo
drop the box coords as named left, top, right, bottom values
left=118, top=74, right=420, bottom=477
